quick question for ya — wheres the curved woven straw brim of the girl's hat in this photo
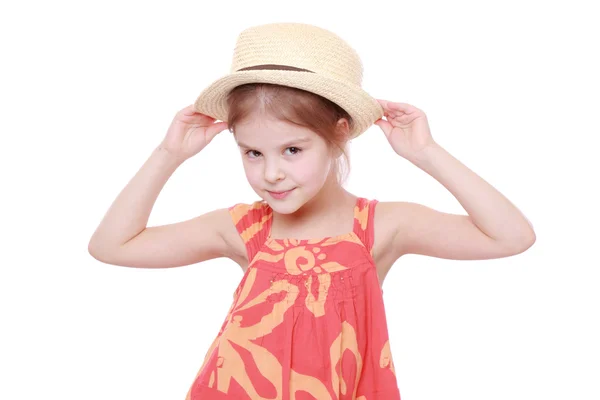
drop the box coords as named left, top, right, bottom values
left=194, top=70, right=383, bottom=138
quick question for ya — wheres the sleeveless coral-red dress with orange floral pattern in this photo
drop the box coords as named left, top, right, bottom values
left=186, top=198, right=400, bottom=400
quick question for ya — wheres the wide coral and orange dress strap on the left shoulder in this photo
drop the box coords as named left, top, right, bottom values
left=229, top=200, right=271, bottom=262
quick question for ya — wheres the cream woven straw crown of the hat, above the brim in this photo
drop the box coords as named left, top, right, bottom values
left=231, top=23, right=363, bottom=86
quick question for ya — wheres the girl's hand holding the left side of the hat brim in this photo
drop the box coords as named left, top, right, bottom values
left=159, top=104, right=228, bottom=162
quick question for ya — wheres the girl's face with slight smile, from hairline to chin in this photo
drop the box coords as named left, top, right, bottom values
left=235, top=115, right=333, bottom=214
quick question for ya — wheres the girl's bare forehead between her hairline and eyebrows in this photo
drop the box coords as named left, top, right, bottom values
left=234, top=115, right=318, bottom=147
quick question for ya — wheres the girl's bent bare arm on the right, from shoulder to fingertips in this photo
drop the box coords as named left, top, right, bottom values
left=375, top=100, right=536, bottom=259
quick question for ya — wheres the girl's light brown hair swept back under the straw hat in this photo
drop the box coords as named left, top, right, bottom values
left=227, top=82, right=354, bottom=185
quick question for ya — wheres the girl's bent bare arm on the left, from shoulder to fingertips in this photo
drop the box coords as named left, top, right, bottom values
left=88, top=106, right=241, bottom=268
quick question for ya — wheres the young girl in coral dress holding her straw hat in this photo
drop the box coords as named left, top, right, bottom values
left=89, top=24, right=535, bottom=400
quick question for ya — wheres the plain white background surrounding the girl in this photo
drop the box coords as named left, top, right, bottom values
left=0, top=0, right=600, bottom=400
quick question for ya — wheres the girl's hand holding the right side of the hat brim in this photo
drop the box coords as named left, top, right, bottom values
left=375, top=99, right=436, bottom=161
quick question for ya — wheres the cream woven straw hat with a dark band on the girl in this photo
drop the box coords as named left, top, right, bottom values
left=194, top=23, right=383, bottom=138
